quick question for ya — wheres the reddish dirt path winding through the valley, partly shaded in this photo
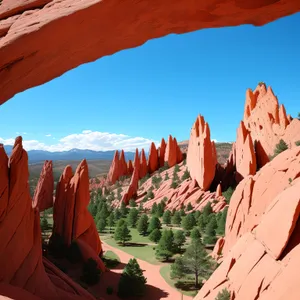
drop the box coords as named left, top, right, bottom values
left=102, top=241, right=193, bottom=300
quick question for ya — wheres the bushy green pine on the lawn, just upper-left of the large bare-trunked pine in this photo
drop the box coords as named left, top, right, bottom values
left=155, top=229, right=176, bottom=260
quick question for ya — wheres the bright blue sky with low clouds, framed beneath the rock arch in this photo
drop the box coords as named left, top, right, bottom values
left=0, top=14, right=300, bottom=150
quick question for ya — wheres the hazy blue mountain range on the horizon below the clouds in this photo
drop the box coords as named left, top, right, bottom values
left=4, top=145, right=135, bottom=163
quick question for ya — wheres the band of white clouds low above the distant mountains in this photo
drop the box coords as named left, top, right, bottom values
left=0, top=130, right=159, bottom=152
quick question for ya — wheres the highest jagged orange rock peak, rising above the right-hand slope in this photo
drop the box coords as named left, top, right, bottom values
left=244, top=84, right=300, bottom=168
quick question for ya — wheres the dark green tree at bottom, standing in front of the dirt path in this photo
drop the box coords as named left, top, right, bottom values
left=118, top=258, right=147, bottom=298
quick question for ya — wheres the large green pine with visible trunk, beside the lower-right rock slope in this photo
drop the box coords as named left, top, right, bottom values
left=173, top=240, right=212, bottom=288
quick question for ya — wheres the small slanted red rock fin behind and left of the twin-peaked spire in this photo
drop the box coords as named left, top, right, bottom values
left=33, top=160, right=54, bottom=212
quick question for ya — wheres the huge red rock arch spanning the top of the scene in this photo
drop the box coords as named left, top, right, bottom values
left=0, top=0, right=300, bottom=104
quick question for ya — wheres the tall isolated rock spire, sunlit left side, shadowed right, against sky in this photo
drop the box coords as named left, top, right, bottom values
left=187, top=115, right=217, bottom=190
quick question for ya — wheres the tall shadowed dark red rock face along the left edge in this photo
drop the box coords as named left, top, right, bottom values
left=0, top=137, right=94, bottom=300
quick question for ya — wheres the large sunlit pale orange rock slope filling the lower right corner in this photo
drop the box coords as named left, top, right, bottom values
left=195, top=147, right=300, bottom=300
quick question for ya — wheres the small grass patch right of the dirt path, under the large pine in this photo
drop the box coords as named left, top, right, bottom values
left=159, top=264, right=198, bottom=297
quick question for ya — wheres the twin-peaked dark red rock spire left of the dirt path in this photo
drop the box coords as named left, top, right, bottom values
left=53, top=160, right=105, bottom=271
